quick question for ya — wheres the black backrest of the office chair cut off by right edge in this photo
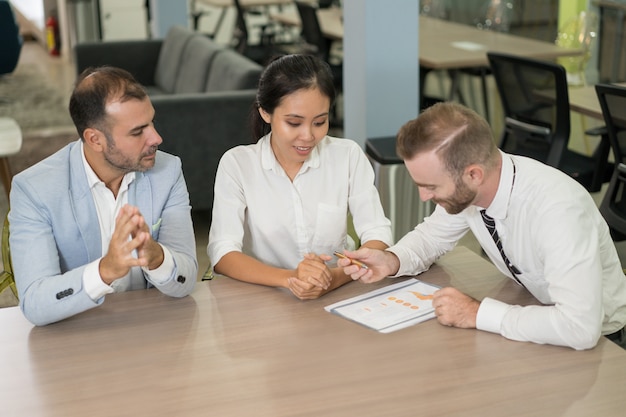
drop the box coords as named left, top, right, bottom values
left=596, top=84, right=626, bottom=165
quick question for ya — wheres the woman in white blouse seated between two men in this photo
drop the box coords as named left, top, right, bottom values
left=207, top=55, right=392, bottom=299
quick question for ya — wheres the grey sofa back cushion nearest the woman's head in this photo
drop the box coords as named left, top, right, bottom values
left=204, top=48, right=263, bottom=92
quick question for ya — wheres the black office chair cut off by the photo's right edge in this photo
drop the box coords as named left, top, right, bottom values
left=596, top=84, right=626, bottom=241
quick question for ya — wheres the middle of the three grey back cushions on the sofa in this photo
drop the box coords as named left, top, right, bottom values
left=174, top=35, right=224, bottom=94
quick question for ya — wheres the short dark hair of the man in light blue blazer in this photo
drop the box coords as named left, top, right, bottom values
left=69, top=66, right=148, bottom=138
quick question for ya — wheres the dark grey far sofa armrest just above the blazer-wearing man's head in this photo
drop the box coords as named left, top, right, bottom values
left=74, top=39, right=163, bottom=86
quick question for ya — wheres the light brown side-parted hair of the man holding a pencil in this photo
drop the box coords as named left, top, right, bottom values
left=396, top=102, right=498, bottom=179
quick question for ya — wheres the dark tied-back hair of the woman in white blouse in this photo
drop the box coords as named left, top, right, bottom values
left=251, top=54, right=336, bottom=139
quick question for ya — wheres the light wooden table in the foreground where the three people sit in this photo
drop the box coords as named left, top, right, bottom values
left=0, top=248, right=626, bottom=417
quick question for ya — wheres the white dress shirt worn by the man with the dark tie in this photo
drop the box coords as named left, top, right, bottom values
left=389, top=153, right=626, bottom=349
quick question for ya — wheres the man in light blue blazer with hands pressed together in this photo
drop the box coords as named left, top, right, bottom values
left=9, top=67, right=198, bottom=325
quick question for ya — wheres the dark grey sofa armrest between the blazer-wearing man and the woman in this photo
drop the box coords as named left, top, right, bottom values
left=152, top=90, right=256, bottom=210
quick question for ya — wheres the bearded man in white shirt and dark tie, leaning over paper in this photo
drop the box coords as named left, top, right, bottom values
left=338, top=103, right=626, bottom=350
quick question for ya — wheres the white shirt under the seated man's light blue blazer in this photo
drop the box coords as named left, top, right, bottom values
left=81, top=142, right=175, bottom=301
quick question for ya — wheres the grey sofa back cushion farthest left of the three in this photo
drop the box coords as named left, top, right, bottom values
left=154, top=26, right=194, bottom=94
